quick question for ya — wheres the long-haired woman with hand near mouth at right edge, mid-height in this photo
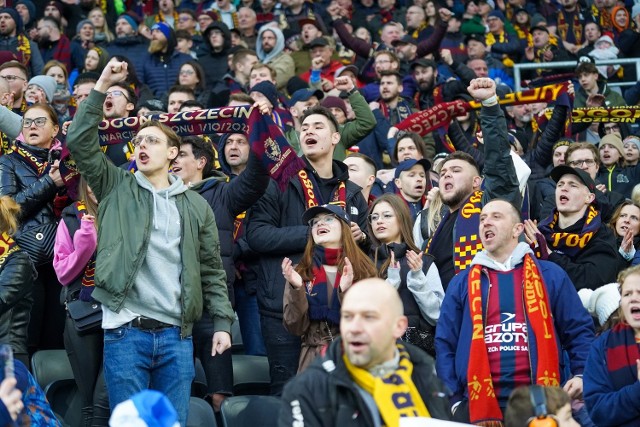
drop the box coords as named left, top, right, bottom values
left=608, top=200, right=640, bottom=271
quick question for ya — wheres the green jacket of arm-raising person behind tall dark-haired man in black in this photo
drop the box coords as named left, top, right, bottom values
left=284, top=91, right=376, bottom=161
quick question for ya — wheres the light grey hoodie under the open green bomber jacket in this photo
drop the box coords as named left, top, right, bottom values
left=103, top=171, right=187, bottom=327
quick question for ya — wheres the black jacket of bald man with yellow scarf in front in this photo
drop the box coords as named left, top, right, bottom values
left=278, top=338, right=449, bottom=427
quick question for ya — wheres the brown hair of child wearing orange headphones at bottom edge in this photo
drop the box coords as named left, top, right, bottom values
left=504, top=386, right=571, bottom=427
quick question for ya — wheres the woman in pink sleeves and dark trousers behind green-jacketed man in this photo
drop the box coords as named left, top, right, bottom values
left=53, top=177, right=109, bottom=426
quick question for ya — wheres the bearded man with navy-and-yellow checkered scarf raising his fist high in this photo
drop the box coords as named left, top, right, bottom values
left=427, top=78, right=522, bottom=290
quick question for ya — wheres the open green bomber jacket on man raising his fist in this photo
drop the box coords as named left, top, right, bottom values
left=67, top=90, right=233, bottom=337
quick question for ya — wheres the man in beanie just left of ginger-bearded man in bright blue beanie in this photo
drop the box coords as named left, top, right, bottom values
left=107, top=12, right=149, bottom=75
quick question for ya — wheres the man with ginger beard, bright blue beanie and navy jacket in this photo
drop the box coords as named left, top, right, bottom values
left=138, top=22, right=191, bottom=98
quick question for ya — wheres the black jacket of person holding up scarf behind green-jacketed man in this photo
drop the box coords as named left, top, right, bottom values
left=192, top=145, right=269, bottom=306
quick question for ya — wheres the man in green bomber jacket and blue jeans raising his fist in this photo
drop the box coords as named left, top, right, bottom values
left=67, top=59, right=233, bottom=425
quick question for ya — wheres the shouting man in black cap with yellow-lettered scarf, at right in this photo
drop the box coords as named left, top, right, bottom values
left=525, top=166, right=618, bottom=290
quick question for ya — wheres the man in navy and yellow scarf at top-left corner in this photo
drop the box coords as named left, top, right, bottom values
left=0, top=7, right=44, bottom=76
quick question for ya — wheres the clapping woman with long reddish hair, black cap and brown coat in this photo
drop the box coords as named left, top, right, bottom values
left=282, top=205, right=376, bottom=372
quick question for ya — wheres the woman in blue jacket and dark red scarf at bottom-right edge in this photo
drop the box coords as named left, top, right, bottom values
left=583, top=265, right=640, bottom=427
